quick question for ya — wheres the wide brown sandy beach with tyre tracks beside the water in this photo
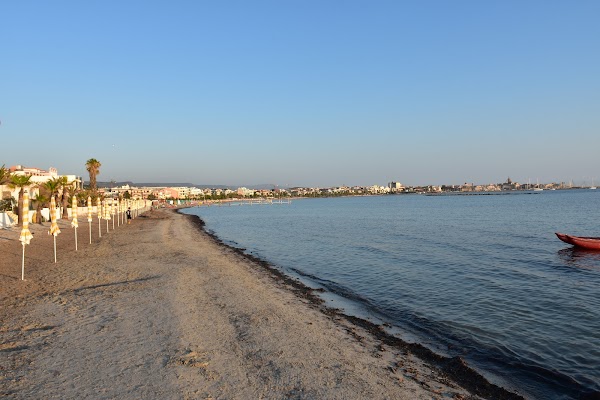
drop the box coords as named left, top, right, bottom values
left=0, top=209, right=519, bottom=399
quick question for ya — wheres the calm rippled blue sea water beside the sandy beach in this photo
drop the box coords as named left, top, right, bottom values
left=184, top=190, right=600, bottom=399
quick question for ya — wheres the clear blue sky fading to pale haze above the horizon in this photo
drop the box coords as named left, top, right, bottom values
left=0, top=0, right=600, bottom=186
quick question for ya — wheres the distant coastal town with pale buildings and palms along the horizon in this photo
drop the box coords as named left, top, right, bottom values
left=0, top=158, right=596, bottom=231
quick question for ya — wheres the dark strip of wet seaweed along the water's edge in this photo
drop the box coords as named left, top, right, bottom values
left=177, top=207, right=524, bottom=399
